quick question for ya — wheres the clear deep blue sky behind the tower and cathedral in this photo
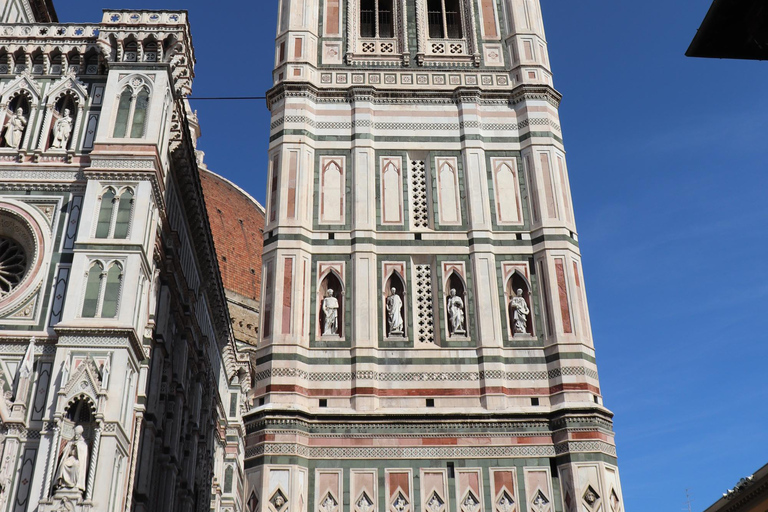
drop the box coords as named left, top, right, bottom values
left=57, top=0, right=768, bottom=512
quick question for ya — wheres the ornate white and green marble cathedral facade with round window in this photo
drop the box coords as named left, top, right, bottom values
left=0, top=0, right=255, bottom=512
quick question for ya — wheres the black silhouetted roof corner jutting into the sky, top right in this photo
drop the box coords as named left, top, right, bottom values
left=685, top=0, right=768, bottom=60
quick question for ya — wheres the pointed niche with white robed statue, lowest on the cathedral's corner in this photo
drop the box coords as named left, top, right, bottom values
left=53, top=398, right=95, bottom=501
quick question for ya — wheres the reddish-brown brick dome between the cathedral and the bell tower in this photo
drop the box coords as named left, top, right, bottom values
left=200, top=167, right=265, bottom=301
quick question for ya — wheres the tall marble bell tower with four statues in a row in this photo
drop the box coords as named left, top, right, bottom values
left=245, top=0, right=623, bottom=512
